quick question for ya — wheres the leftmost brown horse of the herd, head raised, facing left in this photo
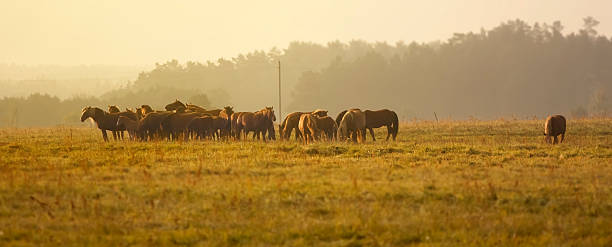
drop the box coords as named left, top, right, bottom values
left=81, top=106, right=137, bottom=141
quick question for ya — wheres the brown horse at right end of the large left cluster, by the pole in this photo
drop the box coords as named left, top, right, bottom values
left=236, top=107, right=276, bottom=141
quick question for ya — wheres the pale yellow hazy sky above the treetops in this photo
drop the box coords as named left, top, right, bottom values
left=0, top=0, right=612, bottom=65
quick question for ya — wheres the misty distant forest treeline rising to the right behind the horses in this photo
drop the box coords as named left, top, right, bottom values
left=0, top=17, right=612, bottom=127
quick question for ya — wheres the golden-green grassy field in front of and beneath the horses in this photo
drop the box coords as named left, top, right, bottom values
left=0, top=119, right=612, bottom=246
